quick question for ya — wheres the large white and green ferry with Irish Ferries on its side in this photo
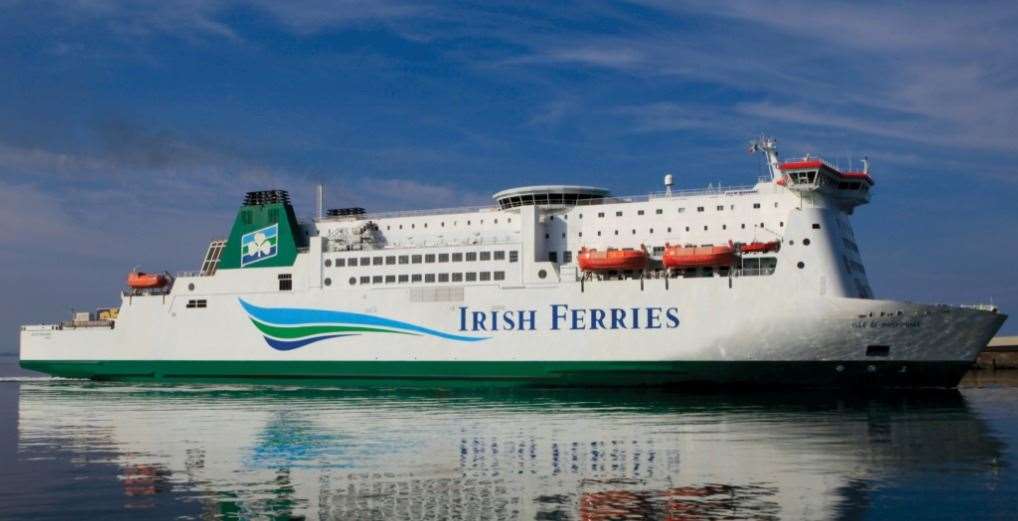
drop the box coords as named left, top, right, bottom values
left=20, top=137, right=1006, bottom=388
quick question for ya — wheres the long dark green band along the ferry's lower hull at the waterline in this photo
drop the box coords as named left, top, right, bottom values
left=15, top=360, right=971, bottom=387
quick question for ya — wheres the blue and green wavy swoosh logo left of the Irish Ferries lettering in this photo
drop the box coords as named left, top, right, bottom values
left=238, top=299, right=490, bottom=351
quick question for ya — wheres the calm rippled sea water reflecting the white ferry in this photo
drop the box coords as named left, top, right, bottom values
left=0, top=358, right=1018, bottom=520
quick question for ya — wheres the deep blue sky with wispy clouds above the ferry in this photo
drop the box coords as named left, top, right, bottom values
left=0, top=0, right=1018, bottom=351
